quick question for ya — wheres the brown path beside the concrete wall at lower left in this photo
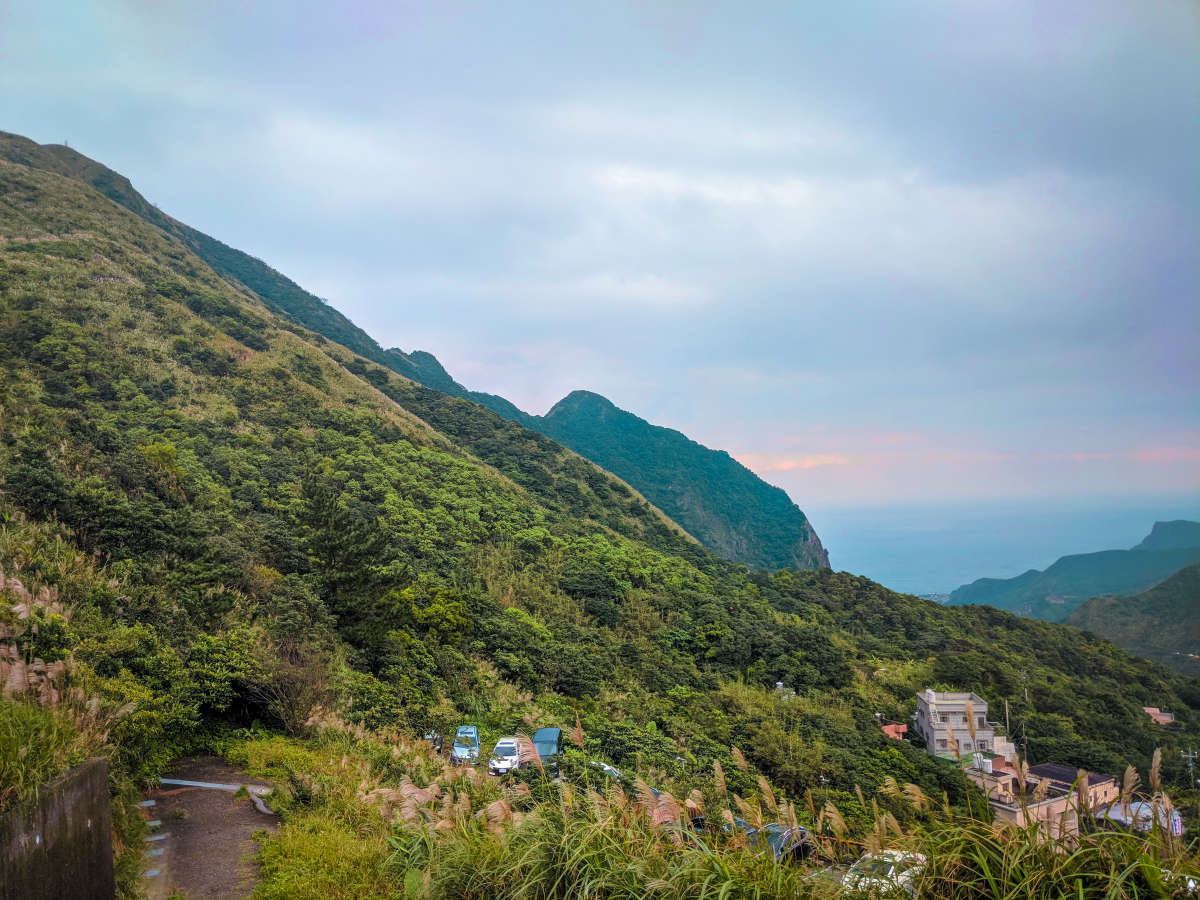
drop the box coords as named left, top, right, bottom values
left=143, top=756, right=278, bottom=900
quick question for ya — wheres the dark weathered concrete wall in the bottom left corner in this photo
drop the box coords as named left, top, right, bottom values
left=0, top=758, right=115, bottom=900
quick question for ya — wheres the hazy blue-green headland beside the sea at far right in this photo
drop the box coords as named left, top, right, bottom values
left=949, top=520, right=1200, bottom=622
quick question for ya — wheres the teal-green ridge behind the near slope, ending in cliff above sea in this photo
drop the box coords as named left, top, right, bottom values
left=0, top=132, right=829, bottom=569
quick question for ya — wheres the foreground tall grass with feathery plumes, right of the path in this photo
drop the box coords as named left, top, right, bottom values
left=233, top=719, right=1198, bottom=900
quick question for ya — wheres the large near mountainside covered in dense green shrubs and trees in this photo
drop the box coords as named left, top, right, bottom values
left=0, top=146, right=1200, bottom=897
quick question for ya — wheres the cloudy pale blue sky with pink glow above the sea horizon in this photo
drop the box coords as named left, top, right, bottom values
left=0, top=0, right=1200, bottom=590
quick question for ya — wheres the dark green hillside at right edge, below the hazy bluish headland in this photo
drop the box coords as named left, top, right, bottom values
left=1063, top=565, right=1200, bottom=678
